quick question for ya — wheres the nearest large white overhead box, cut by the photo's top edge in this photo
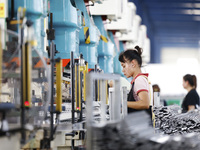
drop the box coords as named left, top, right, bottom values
left=89, top=0, right=123, bottom=20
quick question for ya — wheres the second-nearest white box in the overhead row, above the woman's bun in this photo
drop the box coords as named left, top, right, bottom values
left=107, top=1, right=136, bottom=33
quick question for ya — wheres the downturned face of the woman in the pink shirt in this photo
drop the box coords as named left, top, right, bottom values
left=121, top=62, right=134, bottom=78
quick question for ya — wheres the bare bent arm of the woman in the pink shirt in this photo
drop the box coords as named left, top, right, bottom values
left=127, top=91, right=149, bottom=109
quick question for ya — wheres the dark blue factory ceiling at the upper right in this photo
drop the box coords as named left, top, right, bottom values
left=129, top=0, right=200, bottom=63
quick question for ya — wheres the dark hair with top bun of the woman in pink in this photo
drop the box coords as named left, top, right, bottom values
left=119, top=46, right=142, bottom=67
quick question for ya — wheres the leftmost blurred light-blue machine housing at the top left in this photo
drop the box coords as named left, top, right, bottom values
left=7, top=0, right=49, bottom=58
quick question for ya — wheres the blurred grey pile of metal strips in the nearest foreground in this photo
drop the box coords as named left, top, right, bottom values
left=89, top=112, right=200, bottom=150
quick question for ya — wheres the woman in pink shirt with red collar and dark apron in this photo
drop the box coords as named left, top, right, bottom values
left=119, top=46, right=153, bottom=114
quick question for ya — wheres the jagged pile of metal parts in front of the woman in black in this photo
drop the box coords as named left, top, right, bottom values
left=154, top=105, right=200, bottom=135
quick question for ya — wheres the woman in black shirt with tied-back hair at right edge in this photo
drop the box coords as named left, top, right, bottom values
left=182, top=74, right=199, bottom=112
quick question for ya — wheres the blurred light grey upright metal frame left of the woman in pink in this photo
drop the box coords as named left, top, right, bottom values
left=86, top=73, right=121, bottom=150
